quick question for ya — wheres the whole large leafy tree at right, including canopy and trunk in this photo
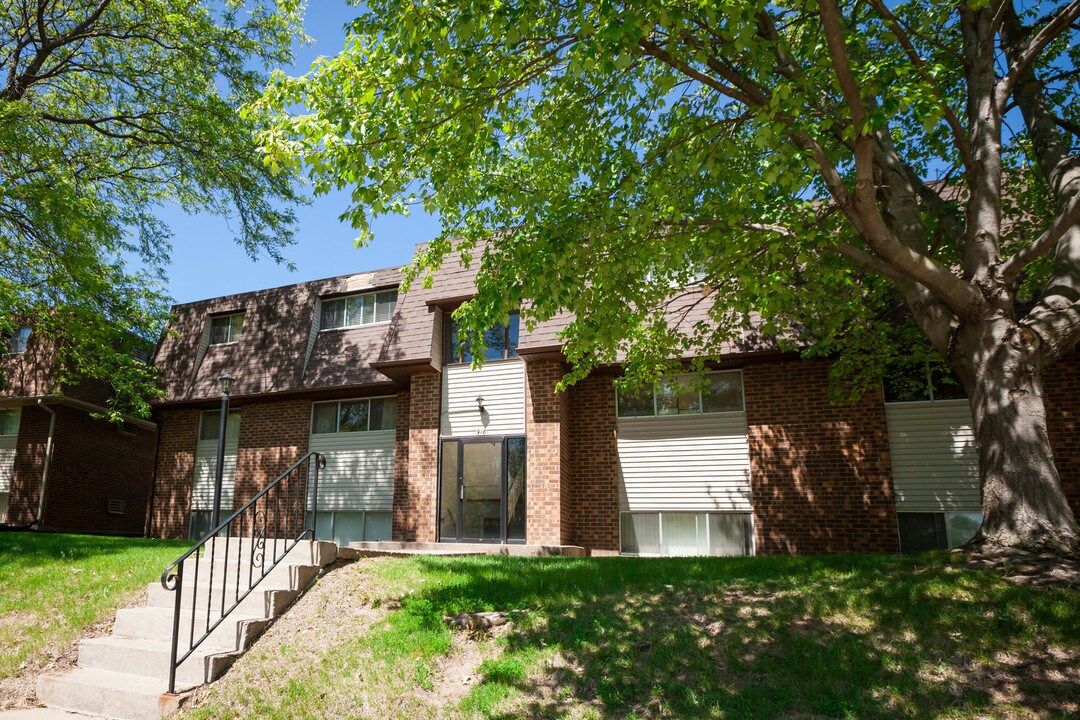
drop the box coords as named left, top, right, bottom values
left=253, top=0, right=1080, bottom=548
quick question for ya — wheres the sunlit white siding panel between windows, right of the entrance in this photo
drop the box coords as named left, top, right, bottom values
left=617, top=412, right=751, bottom=512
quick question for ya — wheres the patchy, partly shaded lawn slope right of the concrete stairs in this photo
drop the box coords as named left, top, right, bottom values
left=181, top=554, right=1080, bottom=720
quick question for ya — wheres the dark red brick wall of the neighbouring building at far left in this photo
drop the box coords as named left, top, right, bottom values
left=8, top=405, right=157, bottom=535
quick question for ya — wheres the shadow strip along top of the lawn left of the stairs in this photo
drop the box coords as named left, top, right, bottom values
left=0, top=531, right=190, bottom=570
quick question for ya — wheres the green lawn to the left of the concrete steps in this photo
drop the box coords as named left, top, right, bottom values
left=0, top=532, right=190, bottom=679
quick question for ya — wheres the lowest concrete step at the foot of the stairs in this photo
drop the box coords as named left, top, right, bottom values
left=38, top=667, right=180, bottom=720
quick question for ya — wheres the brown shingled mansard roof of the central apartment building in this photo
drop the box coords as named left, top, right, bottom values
left=154, top=248, right=775, bottom=403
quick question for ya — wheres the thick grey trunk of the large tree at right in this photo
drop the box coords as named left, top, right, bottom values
left=956, top=317, right=1080, bottom=554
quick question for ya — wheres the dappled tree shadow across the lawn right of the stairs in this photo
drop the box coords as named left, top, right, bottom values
left=413, top=555, right=1080, bottom=720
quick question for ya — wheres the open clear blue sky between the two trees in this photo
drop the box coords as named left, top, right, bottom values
left=160, top=0, right=438, bottom=302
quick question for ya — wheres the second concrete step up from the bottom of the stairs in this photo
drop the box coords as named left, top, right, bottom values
left=79, top=636, right=240, bottom=687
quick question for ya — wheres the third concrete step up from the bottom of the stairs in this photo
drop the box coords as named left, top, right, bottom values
left=112, top=608, right=271, bottom=652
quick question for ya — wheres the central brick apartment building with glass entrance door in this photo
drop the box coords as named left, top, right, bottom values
left=139, top=248, right=1080, bottom=555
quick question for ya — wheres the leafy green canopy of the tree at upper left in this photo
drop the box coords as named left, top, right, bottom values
left=0, top=0, right=299, bottom=413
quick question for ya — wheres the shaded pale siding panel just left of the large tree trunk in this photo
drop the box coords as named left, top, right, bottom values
left=886, top=399, right=982, bottom=513
